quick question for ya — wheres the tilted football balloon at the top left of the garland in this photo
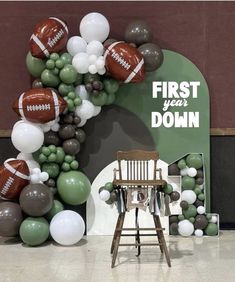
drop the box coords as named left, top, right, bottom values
left=29, top=17, right=68, bottom=59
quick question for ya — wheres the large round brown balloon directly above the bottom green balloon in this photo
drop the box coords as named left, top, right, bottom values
left=19, top=183, right=53, bottom=216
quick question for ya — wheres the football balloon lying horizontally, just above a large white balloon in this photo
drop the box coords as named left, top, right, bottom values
left=12, top=88, right=67, bottom=123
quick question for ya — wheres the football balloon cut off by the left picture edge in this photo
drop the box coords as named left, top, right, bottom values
left=0, top=159, right=30, bottom=200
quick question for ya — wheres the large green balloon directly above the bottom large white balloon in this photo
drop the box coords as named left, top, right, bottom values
left=57, top=171, right=91, bottom=205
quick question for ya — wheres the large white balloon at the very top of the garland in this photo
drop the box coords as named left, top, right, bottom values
left=79, top=13, right=110, bottom=43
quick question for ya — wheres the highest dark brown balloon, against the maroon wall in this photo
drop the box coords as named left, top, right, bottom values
left=125, top=20, right=153, bottom=46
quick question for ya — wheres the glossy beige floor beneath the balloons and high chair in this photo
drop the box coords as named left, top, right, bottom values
left=0, top=231, right=235, bottom=282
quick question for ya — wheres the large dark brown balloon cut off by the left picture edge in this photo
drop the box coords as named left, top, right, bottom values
left=0, top=202, right=23, bottom=237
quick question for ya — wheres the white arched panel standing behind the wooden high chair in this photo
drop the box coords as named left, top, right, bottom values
left=86, top=160, right=182, bottom=235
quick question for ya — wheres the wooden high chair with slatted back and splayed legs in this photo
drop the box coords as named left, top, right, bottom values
left=111, top=150, right=171, bottom=268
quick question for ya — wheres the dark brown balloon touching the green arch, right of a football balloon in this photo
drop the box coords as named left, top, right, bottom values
left=138, top=43, right=164, bottom=71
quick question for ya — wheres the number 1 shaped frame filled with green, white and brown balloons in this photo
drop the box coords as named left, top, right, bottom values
left=168, top=153, right=218, bottom=237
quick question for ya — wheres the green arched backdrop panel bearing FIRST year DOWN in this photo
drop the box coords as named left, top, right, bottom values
left=115, top=50, right=210, bottom=211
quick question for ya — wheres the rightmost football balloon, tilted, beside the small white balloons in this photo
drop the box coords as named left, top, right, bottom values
left=104, top=42, right=145, bottom=83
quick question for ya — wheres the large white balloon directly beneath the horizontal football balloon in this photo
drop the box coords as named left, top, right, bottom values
left=11, top=121, right=44, bottom=153
